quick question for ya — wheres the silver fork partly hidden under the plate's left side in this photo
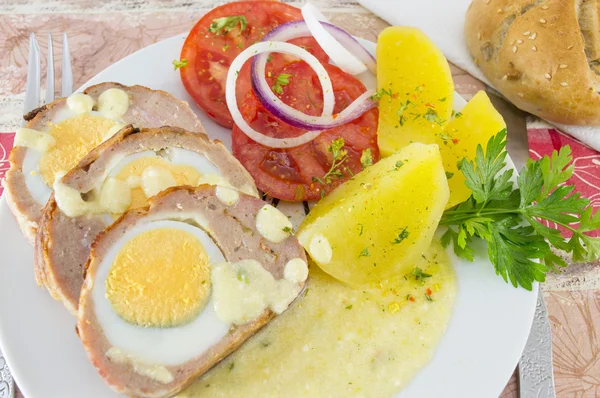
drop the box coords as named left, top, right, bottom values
left=0, top=33, right=73, bottom=398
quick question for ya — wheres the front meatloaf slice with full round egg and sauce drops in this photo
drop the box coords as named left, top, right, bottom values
left=77, top=185, right=308, bottom=397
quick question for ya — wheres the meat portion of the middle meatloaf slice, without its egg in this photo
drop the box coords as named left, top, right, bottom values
left=35, top=126, right=258, bottom=315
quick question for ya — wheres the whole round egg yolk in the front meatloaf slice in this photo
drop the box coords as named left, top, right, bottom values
left=106, top=228, right=211, bottom=327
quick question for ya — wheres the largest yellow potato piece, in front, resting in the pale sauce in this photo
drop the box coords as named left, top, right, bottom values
left=298, top=143, right=449, bottom=285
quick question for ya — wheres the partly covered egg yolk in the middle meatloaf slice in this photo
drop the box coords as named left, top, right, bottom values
left=116, top=156, right=200, bottom=209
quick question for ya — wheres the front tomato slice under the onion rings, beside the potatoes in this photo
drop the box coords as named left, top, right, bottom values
left=232, top=61, right=379, bottom=201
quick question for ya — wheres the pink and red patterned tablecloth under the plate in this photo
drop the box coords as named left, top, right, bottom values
left=0, top=0, right=600, bottom=398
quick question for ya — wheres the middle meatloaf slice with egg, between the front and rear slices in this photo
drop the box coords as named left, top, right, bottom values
left=35, top=126, right=258, bottom=314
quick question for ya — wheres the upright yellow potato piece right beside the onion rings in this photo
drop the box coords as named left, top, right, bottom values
left=377, top=26, right=454, bottom=157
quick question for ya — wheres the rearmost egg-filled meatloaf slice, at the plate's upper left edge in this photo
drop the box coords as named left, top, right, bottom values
left=5, top=83, right=204, bottom=244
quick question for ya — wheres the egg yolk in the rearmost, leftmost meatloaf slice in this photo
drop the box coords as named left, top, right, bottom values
left=38, top=114, right=115, bottom=187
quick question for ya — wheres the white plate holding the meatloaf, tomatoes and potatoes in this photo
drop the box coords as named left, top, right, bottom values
left=0, top=35, right=538, bottom=398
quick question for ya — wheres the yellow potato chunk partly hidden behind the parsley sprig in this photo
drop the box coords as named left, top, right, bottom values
left=437, top=91, right=506, bottom=208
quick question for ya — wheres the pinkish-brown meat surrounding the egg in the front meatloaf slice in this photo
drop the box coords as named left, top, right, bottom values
left=77, top=185, right=307, bottom=397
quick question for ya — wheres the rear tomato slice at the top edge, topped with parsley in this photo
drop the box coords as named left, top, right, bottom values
left=180, top=1, right=328, bottom=128
